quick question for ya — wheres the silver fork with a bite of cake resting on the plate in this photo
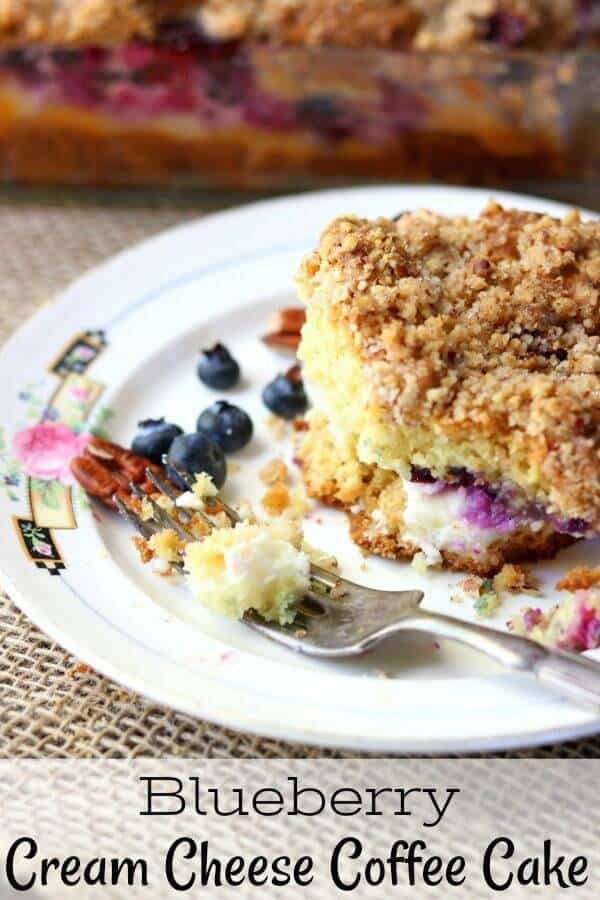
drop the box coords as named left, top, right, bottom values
left=113, top=469, right=600, bottom=706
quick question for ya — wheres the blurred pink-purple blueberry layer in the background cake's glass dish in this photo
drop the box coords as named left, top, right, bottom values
left=0, top=21, right=425, bottom=144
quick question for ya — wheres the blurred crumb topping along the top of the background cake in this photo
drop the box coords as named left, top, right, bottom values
left=0, top=0, right=598, bottom=51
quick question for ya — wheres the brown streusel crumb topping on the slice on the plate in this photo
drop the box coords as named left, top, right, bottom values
left=299, top=202, right=600, bottom=530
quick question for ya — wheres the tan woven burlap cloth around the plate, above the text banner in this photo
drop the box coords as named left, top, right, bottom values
left=0, top=189, right=600, bottom=758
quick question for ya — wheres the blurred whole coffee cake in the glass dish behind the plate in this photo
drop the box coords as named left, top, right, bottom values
left=0, top=0, right=600, bottom=186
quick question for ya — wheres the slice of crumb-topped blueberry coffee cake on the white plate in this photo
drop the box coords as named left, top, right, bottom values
left=298, top=202, right=600, bottom=575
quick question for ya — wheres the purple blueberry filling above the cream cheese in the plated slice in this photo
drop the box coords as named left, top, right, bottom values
left=410, top=466, right=591, bottom=537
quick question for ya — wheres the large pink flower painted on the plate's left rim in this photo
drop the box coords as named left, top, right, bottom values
left=13, top=422, right=91, bottom=484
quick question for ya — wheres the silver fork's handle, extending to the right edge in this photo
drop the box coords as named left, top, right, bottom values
left=414, top=610, right=600, bottom=707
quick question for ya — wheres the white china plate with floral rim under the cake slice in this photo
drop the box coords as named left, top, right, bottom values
left=0, top=187, right=600, bottom=753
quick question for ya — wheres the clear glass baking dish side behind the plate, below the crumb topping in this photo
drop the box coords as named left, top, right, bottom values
left=0, top=30, right=600, bottom=188
